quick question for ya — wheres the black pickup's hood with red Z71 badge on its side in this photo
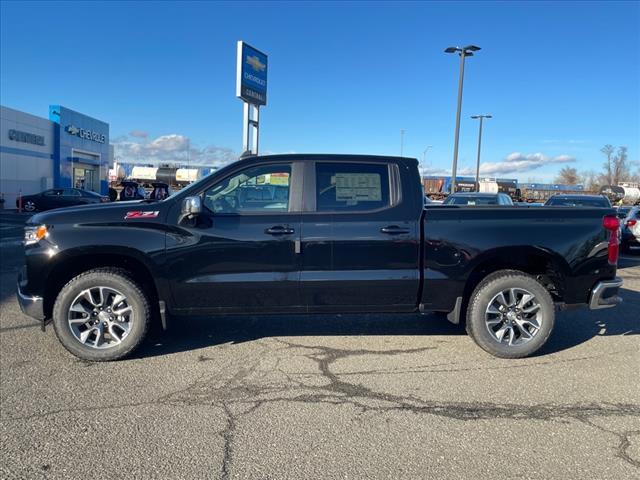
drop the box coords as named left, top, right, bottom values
left=27, top=200, right=166, bottom=225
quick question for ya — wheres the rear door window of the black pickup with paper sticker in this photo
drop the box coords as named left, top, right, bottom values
left=316, top=162, right=391, bottom=212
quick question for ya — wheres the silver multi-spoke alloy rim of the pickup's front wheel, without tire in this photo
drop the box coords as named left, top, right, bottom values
left=67, top=286, right=133, bottom=349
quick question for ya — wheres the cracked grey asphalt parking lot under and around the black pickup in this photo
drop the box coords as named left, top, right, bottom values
left=0, top=214, right=640, bottom=480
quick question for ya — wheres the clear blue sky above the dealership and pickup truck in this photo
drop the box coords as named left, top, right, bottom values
left=0, top=1, right=640, bottom=180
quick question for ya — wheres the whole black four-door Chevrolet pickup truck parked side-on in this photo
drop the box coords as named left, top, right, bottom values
left=18, top=155, right=622, bottom=361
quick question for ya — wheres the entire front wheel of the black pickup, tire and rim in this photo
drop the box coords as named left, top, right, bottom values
left=53, top=268, right=150, bottom=362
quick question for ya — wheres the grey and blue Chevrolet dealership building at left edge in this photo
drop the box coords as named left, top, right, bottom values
left=0, top=105, right=113, bottom=208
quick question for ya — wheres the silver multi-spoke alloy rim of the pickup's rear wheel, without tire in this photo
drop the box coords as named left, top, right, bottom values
left=484, top=288, right=542, bottom=346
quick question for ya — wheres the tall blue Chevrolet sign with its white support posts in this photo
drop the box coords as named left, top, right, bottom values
left=236, top=41, right=267, bottom=155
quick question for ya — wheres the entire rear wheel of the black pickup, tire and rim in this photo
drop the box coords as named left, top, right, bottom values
left=467, top=270, right=555, bottom=358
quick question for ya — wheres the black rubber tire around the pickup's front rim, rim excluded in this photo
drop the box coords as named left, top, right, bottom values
left=53, top=268, right=151, bottom=362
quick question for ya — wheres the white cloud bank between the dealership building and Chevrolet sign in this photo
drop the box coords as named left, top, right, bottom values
left=113, top=130, right=238, bottom=167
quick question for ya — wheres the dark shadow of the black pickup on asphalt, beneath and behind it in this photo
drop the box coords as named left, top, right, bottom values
left=134, top=289, right=640, bottom=358
